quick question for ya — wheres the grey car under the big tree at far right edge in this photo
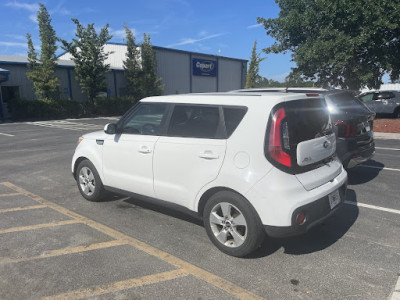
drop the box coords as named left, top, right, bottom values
left=358, top=91, right=400, bottom=118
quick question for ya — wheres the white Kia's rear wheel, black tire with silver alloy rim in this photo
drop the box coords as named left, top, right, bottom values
left=203, top=191, right=266, bottom=257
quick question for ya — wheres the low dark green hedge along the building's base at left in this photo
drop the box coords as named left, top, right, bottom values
left=8, top=97, right=136, bottom=120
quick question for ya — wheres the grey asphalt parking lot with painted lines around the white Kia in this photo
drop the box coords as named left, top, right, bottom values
left=0, top=118, right=400, bottom=299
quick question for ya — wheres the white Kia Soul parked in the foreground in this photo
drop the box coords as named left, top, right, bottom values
left=72, top=93, right=347, bottom=256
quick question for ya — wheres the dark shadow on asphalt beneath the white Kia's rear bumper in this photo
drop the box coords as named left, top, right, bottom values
left=248, top=189, right=359, bottom=258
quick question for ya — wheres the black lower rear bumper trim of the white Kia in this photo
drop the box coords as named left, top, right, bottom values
left=264, top=181, right=347, bottom=237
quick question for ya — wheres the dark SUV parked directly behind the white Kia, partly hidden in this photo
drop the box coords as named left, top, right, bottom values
left=232, top=88, right=375, bottom=169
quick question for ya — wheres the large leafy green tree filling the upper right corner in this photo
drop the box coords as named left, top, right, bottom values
left=258, top=0, right=400, bottom=89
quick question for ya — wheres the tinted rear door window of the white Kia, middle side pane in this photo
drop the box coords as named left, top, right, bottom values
left=167, top=105, right=220, bottom=139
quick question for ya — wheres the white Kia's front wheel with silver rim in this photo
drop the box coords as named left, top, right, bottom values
left=75, top=159, right=105, bottom=202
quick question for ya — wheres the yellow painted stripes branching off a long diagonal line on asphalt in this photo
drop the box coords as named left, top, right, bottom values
left=0, top=182, right=263, bottom=299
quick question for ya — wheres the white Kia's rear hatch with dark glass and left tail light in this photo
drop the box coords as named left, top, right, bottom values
left=265, top=95, right=342, bottom=190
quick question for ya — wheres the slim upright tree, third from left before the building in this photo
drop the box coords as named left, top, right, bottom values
left=124, top=24, right=143, bottom=99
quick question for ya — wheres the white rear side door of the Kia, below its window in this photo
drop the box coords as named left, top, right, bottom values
left=153, top=137, right=226, bottom=209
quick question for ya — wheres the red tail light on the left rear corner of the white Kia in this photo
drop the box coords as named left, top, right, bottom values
left=268, top=108, right=292, bottom=167
